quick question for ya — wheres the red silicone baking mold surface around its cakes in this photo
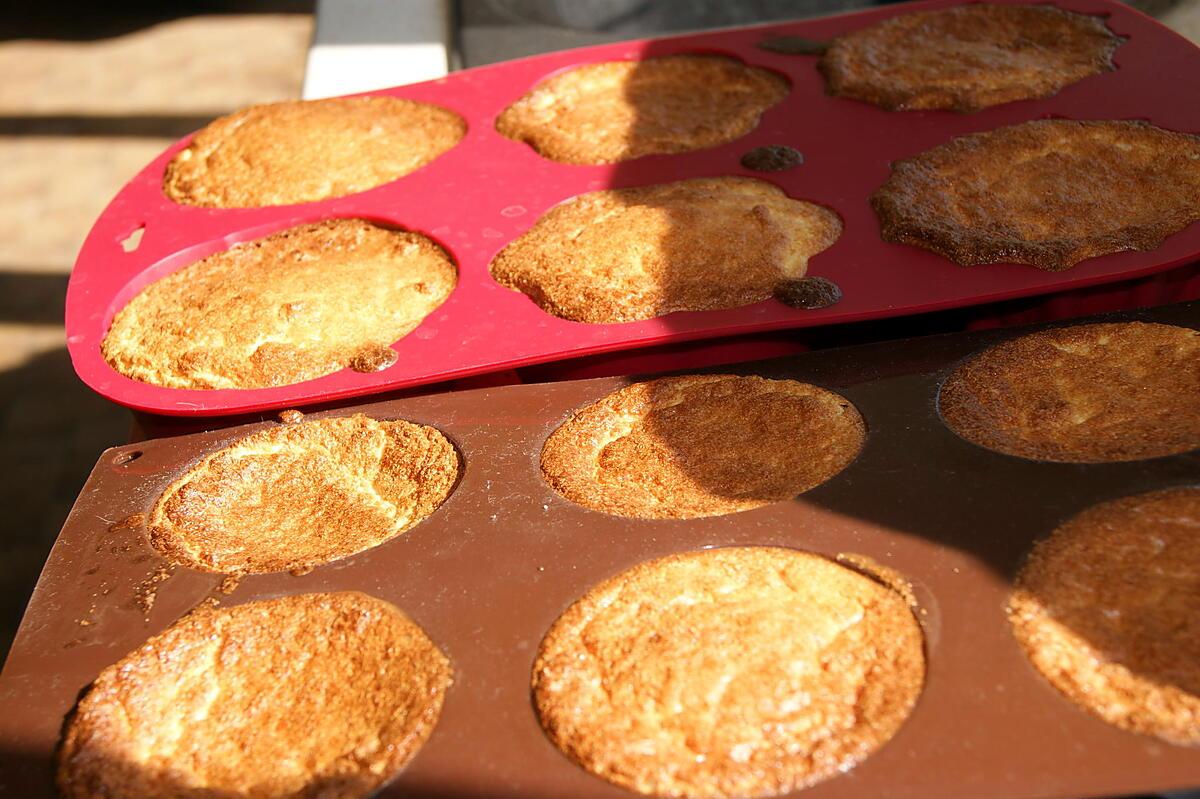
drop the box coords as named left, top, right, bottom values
left=66, top=0, right=1200, bottom=415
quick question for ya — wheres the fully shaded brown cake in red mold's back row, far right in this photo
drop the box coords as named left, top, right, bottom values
left=817, top=4, right=1124, bottom=112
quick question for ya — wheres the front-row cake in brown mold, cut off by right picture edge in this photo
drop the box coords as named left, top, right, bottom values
left=1008, top=488, right=1200, bottom=746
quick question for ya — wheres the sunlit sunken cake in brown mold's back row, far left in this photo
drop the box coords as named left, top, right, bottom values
left=149, top=415, right=460, bottom=573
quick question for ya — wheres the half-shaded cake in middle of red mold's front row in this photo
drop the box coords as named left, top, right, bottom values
left=491, top=178, right=841, bottom=324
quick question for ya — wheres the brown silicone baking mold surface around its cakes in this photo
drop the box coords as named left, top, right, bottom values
left=0, top=302, right=1200, bottom=799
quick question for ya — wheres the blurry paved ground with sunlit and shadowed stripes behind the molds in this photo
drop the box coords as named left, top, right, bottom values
left=0, top=0, right=1200, bottom=656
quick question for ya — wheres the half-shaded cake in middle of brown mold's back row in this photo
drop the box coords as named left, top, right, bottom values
left=541, top=374, right=866, bottom=518
